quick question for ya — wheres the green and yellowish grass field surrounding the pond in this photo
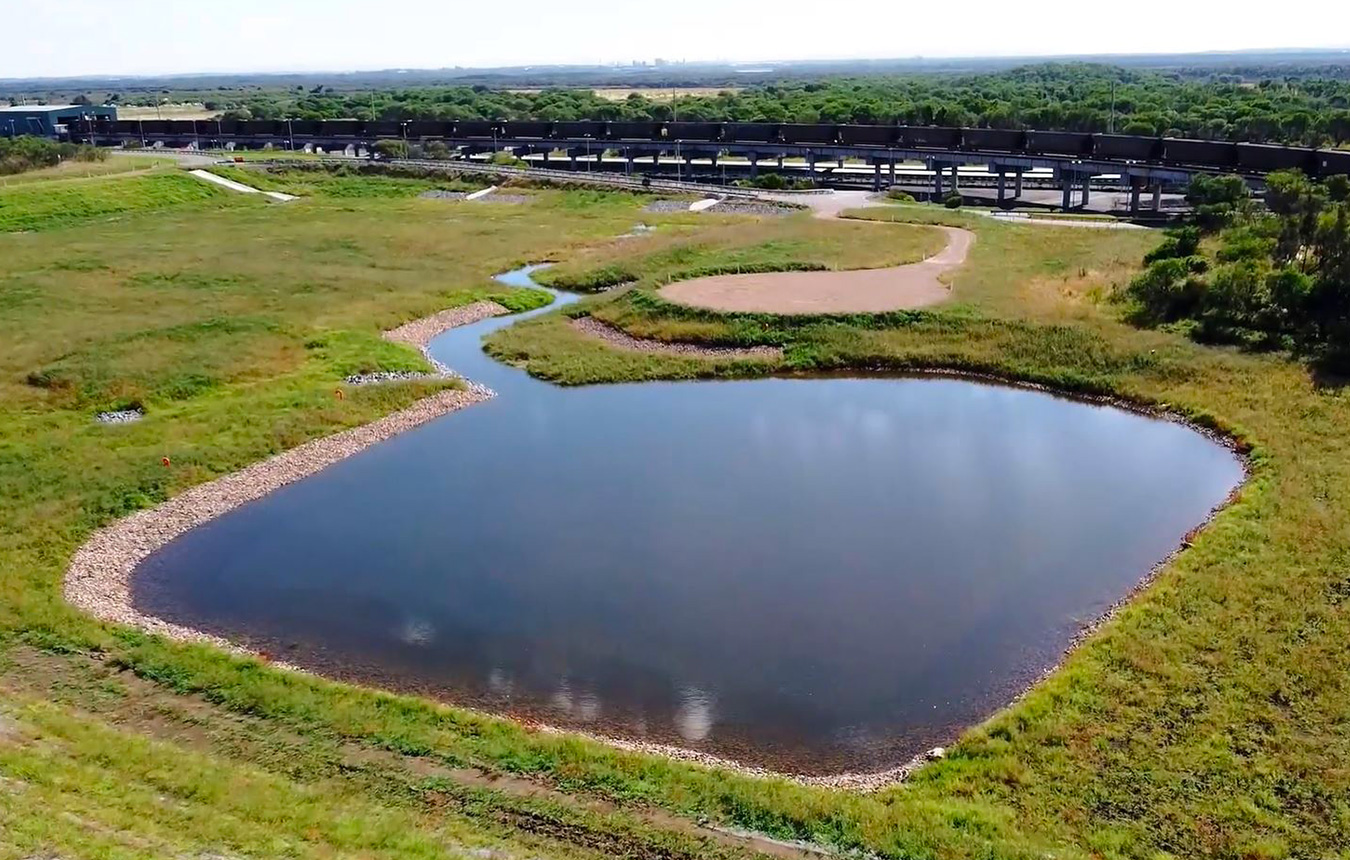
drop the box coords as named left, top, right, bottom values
left=0, top=174, right=1350, bottom=860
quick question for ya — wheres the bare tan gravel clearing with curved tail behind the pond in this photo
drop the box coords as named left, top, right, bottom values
left=660, top=227, right=975, bottom=313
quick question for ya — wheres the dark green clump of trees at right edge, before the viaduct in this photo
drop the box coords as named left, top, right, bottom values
left=1126, top=171, right=1350, bottom=373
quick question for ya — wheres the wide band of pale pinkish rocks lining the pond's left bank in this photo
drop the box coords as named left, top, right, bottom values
left=65, top=301, right=506, bottom=653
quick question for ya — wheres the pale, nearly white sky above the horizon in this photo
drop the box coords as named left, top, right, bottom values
left=0, top=0, right=1350, bottom=78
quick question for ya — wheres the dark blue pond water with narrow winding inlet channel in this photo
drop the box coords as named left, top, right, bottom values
left=135, top=267, right=1242, bottom=772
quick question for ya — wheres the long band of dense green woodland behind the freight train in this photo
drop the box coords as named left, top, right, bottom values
left=207, top=63, right=1350, bottom=146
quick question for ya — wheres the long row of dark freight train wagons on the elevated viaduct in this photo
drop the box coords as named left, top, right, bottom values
left=68, top=119, right=1350, bottom=176
